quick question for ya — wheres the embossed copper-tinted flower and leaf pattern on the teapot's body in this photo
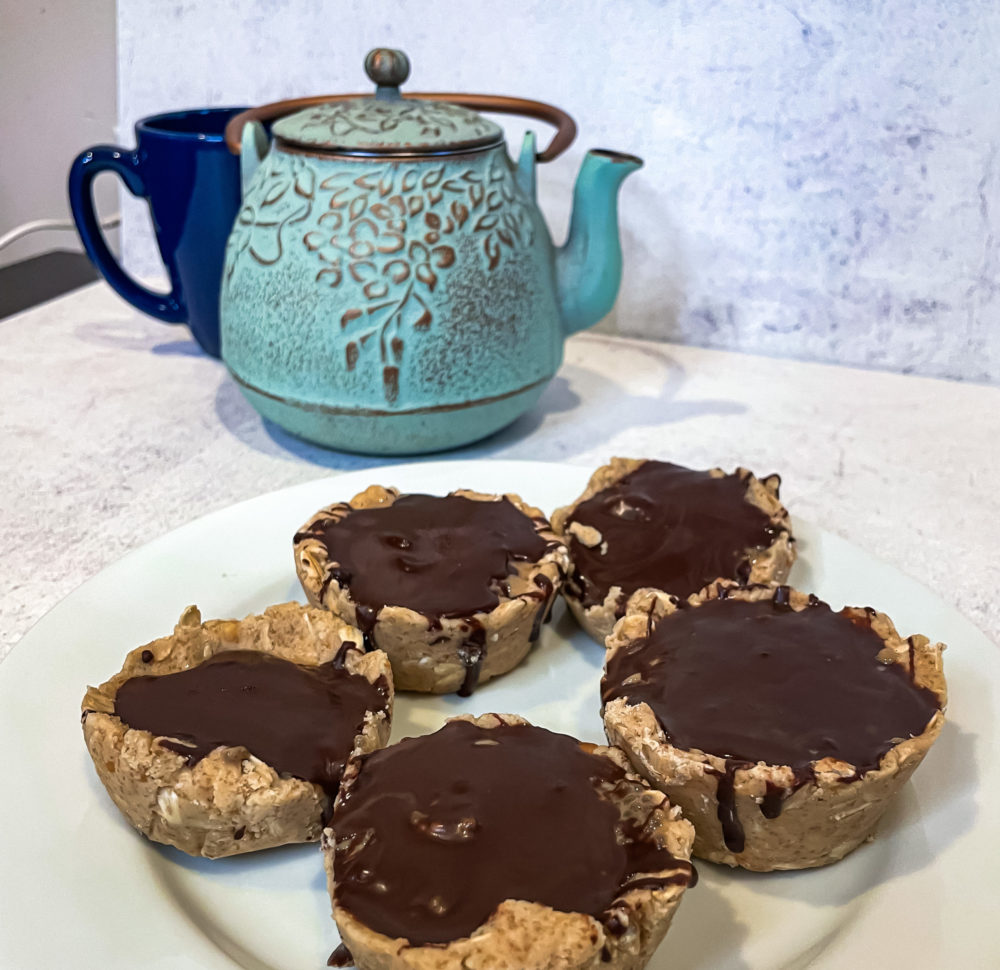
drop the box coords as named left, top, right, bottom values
left=225, top=152, right=535, bottom=403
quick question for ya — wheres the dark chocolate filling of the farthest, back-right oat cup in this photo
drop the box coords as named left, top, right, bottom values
left=567, top=461, right=780, bottom=609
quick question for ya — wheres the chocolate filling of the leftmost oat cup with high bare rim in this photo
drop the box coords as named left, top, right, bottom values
left=115, top=649, right=388, bottom=798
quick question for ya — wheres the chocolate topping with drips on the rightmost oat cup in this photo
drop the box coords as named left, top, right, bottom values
left=601, top=587, right=941, bottom=852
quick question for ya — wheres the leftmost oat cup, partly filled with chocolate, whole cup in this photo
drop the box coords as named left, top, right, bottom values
left=83, top=603, right=392, bottom=859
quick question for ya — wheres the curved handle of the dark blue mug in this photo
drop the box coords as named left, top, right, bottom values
left=69, top=145, right=187, bottom=323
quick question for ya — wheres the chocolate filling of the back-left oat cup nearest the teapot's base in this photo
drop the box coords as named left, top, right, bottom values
left=295, top=495, right=549, bottom=622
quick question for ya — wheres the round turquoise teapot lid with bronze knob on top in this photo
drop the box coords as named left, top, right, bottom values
left=272, top=48, right=503, bottom=155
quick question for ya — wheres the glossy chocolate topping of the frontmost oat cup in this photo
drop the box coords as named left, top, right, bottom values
left=332, top=721, right=691, bottom=944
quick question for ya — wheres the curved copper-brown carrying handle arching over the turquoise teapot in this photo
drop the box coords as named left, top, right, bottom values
left=226, top=92, right=576, bottom=162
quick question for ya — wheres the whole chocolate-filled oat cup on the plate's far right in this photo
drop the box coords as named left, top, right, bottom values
left=601, top=583, right=947, bottom=872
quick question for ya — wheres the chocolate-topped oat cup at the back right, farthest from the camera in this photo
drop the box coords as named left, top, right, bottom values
left=552, top=458, right=795, bottom=645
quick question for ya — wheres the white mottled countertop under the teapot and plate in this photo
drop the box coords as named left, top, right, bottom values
left=0, top=283, right=1000, bottom=658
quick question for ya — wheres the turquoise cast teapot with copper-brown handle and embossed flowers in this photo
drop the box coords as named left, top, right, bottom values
left=220, top=49, right=642, bottom=455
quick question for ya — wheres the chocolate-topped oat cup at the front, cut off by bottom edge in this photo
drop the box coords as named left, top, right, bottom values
left=323, top=714, right=694, bottom=970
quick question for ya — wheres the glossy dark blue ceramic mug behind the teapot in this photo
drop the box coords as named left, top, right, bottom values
left=69, top=108, right=244, bottom=357
